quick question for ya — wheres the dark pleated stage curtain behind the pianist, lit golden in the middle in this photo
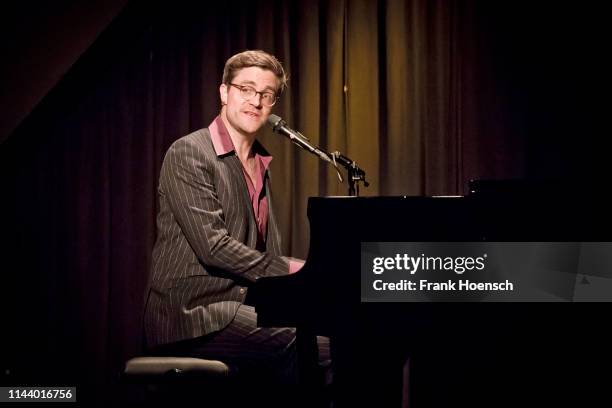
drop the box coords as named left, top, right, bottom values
left=0, top=0, right=607, bottom=401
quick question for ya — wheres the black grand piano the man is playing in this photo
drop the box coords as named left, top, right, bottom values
left=251, top=180, right=612, bottom=408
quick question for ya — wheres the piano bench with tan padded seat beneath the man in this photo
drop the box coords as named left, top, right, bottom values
left=121, top=356, right=234, bottom=406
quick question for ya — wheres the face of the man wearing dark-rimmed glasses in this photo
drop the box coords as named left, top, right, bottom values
left=219, top=67, right=279, bottom=135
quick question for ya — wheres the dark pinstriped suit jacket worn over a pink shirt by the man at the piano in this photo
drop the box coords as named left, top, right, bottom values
left=144, top=129, right=289, bottom=347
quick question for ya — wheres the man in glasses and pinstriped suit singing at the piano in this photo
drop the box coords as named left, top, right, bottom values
left=145, top=51, right=329, bottom=383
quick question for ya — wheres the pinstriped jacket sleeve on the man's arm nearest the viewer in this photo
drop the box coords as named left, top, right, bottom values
left=160, top=138, right=289, bottom=282
